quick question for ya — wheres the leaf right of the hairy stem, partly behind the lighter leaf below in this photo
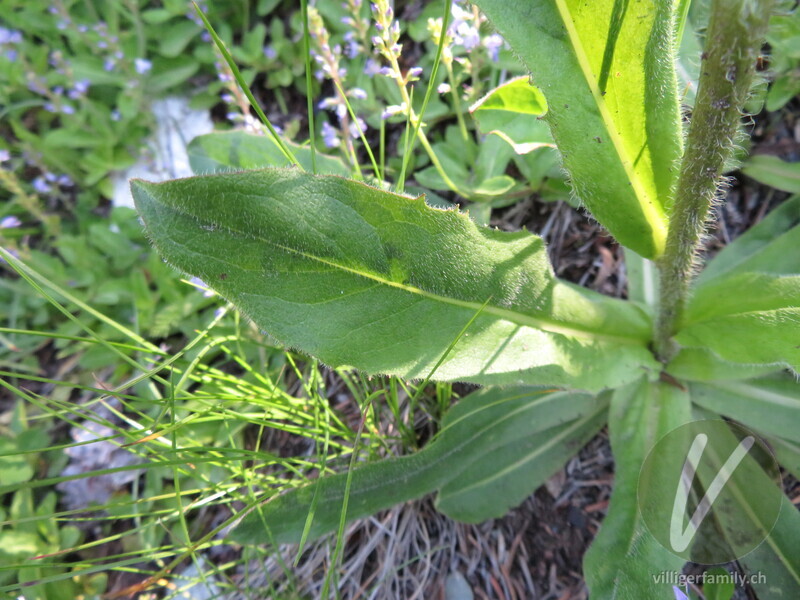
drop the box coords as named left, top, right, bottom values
left=697, top=196, right=800, bottom=287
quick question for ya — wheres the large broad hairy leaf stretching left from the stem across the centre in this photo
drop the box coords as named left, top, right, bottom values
left=132, top=169, right=660, bottom=390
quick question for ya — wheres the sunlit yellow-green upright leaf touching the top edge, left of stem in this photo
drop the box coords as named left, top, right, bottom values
left=476, top=0, right=682, bottom=259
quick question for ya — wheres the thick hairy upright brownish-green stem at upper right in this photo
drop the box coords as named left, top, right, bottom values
left=654, top=0, right=772, bottom=362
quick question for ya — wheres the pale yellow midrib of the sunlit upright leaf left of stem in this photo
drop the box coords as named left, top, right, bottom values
left=556, top=0, right=667, bottom=253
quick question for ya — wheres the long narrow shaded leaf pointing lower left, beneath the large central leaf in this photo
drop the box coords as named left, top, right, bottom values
left=231, top=388, right=605, bottom=544
